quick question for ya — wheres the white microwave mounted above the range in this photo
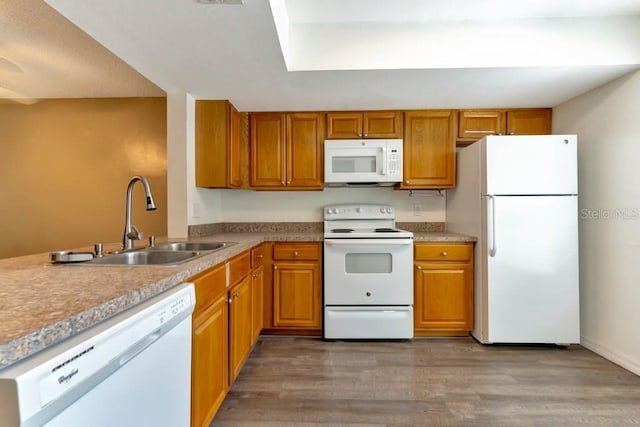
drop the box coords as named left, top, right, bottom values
left=324, top=139, right=402, bottom=187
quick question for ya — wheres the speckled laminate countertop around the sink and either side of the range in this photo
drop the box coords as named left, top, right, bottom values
left=0, top=232, right=475, bottom=369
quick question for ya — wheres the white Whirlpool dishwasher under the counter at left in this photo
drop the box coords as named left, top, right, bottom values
left=0, top=283, right=195, bottom=427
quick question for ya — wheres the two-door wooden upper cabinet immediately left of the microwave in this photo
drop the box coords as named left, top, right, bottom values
left=249, top=113, right=325, bottom=190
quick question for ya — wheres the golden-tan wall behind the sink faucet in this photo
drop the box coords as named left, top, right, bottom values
left=0, top=98, right=167, bottom=258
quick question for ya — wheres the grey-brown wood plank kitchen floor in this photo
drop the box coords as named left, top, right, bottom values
left=212, top=337, right=640, bottom=427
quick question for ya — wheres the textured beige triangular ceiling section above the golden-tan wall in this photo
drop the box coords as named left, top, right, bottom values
left=0, top=0, right=164, bottom=103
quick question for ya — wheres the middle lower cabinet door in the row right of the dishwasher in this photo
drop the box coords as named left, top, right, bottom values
left=229, top=275, right=253, bottom=384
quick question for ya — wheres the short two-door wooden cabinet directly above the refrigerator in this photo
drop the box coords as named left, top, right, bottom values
left=458, top=108, right=551, bottom=145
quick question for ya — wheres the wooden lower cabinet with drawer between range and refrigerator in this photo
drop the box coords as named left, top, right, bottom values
left=414, top=243, right=473, bottom=336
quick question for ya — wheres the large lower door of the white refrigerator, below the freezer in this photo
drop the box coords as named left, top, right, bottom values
left=483, top=196, right=580, bottom=344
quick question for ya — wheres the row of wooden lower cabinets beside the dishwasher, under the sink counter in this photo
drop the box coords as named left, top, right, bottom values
left=189, top=245, right=263, bottom=427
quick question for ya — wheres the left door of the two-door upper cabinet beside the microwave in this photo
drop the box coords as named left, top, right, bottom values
left=249, top=113, right=286, bottom=188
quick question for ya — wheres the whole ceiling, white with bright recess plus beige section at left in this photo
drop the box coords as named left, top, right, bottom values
left=0, top=0, right=640, bottom=111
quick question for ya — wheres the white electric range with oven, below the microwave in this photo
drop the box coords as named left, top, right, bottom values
left=323, top=204, right=413, bottom=339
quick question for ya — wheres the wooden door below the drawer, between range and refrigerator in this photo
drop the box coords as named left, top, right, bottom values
left=414, top=262, right=473, bottom=331
